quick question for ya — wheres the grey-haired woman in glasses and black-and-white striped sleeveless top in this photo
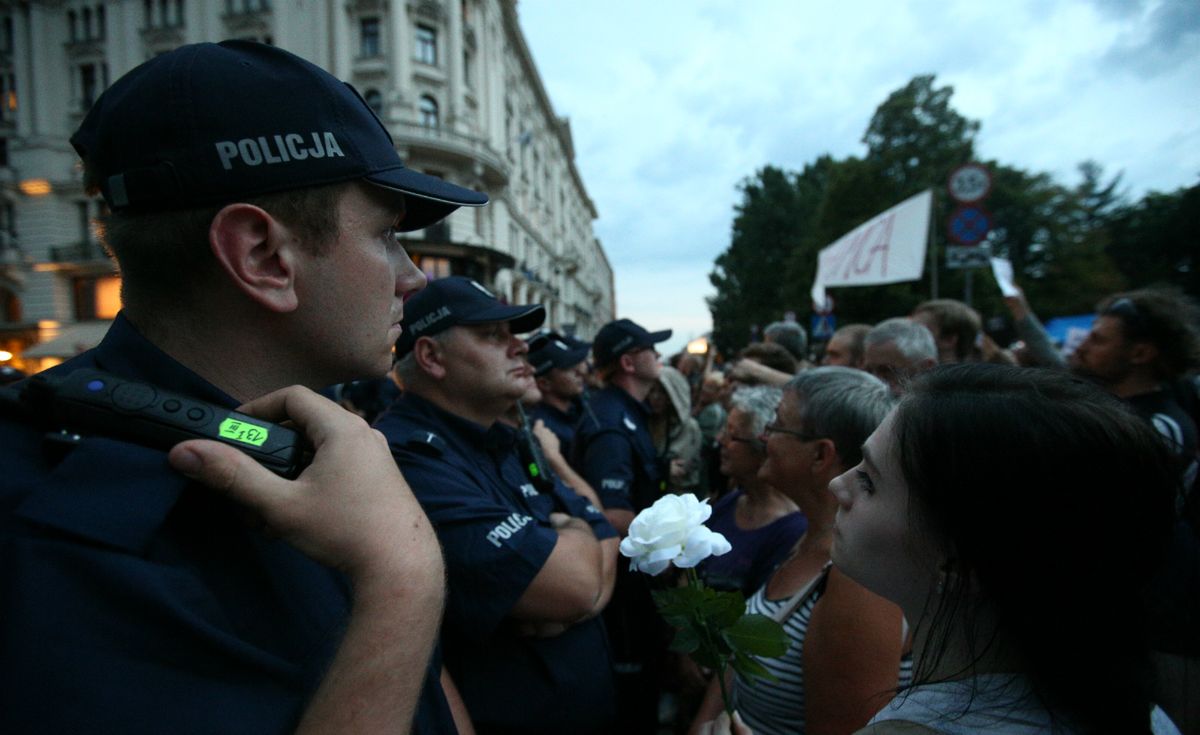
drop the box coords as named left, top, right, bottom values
left=692, top=368, right=911, bottom=735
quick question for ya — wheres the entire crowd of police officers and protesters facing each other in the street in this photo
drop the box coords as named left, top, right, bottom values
left=0, top=42, right=1200, bottom=735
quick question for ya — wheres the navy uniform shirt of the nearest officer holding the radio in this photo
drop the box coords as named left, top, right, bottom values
left=0, top=315, right=455, bottom=735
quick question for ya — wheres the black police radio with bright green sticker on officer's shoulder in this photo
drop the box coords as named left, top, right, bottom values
left=8, top=368, right=312, bottom=479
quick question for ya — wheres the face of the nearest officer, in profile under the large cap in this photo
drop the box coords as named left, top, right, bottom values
left=296, top=184, right=425, bottom=383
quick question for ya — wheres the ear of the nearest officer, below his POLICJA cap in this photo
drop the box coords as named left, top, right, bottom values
left=209, top=203, right=299, bottom=312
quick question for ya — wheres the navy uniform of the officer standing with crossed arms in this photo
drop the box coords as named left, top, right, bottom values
left=376, top=393, right=616, bottom=733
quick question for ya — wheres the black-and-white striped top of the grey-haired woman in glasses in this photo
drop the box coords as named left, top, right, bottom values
left=733, top=568, right=912, bottom=735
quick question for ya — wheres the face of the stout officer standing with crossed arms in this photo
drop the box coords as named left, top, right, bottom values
left=443, top=322, right=534, bottom=407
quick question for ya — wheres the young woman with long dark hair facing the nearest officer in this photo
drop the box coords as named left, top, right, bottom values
left=830, top=364, right=1178, bottom=734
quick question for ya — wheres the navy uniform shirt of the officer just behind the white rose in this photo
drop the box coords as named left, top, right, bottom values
left=572, top=386, right=662, bottom=513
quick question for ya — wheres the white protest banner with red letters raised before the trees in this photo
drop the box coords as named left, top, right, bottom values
left=812, top=190, right=934, bottom=311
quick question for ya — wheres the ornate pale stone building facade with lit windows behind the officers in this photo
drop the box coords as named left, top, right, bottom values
left=0, top=0, right=614, bottom=370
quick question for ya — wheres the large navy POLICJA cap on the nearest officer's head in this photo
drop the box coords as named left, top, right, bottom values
left=71, top=41, right=487, bottom=231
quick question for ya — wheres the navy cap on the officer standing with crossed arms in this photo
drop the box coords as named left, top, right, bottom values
left=396, top=276, right=546, bottom=359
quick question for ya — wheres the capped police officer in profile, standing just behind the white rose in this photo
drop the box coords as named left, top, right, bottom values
left=574, top=319, right=671, bottom=733
